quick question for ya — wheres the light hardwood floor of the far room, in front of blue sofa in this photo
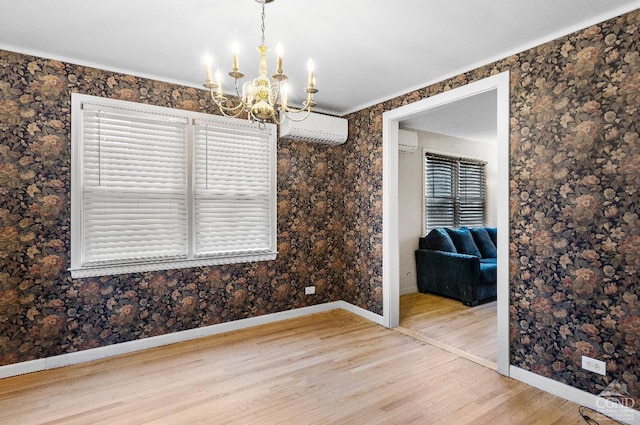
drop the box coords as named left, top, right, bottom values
left=399, top=292, right=497, bottom=369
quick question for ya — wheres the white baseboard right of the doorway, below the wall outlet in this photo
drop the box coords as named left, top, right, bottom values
left=509, top=366, right=640, bottom=425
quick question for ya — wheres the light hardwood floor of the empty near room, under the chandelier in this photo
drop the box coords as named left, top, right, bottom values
left=0, top=310, right=605, bottom=425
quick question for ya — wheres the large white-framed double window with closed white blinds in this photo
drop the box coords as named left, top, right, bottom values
left=71, top=94, right=276, bottom=278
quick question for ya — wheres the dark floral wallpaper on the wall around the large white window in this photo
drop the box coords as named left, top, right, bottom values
left=0, top=51, right=345, bottom=365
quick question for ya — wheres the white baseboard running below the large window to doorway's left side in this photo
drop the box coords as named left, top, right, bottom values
left=0, top=301, right=370, bottom=379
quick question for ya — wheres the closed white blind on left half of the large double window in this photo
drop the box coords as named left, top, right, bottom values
left=82, top=104, right=187, bottom=266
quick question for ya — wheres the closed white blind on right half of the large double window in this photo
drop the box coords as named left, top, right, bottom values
left=195, top=121, right=274, bottom=256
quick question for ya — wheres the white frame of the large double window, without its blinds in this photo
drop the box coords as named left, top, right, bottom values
left=69, top=93, right=277, bottom=278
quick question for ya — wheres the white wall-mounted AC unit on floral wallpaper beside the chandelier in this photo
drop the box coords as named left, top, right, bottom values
left=280, top=112, right=349, bottom=145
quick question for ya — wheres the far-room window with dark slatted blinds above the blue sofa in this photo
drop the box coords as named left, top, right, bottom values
left=424, top=152, right=486, bottom=233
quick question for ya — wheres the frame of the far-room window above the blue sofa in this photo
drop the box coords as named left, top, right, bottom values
left=422, top=149, right=488, bottom=234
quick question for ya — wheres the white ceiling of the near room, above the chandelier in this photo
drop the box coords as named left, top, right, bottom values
left=0, top=0, right=640, bottom=114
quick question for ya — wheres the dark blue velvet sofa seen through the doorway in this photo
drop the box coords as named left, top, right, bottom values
left=416, top=227, right=498, bottom=306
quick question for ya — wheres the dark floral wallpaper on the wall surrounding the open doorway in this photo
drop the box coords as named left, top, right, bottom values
left=345, top=11, right=640, bottom=408
